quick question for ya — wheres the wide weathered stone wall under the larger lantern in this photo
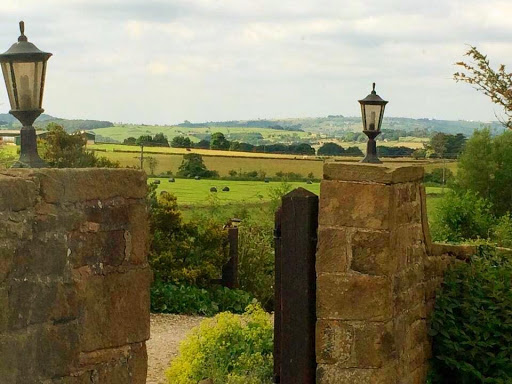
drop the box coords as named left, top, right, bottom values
left=0, top=169, right=151, bottom=384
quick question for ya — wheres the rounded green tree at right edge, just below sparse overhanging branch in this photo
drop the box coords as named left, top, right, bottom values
left=457, top=128, right=512, bottom=216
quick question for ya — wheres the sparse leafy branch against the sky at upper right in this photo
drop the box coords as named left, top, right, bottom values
left=453, top=47, right=512, bottom=129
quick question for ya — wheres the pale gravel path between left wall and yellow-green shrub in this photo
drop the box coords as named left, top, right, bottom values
left=146, top=313, right=204, bottom=384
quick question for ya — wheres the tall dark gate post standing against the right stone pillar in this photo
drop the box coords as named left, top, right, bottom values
left=274, top=188, right=318, bottom=384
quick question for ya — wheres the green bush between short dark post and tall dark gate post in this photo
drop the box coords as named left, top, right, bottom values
left=238, top=225, right=274, bottom=310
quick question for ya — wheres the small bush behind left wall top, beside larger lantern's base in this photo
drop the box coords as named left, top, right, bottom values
left=40, top=123, right=119, bottom=168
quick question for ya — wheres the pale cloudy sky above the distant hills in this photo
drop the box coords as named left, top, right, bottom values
left=0, top=0, right=512, bottom=124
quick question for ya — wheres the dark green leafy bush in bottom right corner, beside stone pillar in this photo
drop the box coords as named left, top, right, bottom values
left=430, top=248, right=512, bottom=384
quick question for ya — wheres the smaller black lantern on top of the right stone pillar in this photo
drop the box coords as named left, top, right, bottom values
left=359, top=83, right=388, bottom=164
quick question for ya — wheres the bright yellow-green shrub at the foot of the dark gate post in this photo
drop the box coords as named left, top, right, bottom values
left=166, top=306, right=273, bottom=384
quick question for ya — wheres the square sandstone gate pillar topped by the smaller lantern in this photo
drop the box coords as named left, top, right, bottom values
left=316, top=163, right=430, bottom=384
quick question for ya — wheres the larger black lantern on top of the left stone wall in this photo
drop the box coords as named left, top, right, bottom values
left=0, top=21, right=52, bottom=168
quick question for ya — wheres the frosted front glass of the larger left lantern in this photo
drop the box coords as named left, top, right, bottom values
left=12, top=61, right=43, bottom=111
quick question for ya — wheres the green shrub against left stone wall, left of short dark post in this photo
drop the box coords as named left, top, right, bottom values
left=149, top=189, right=229, bottom=286
